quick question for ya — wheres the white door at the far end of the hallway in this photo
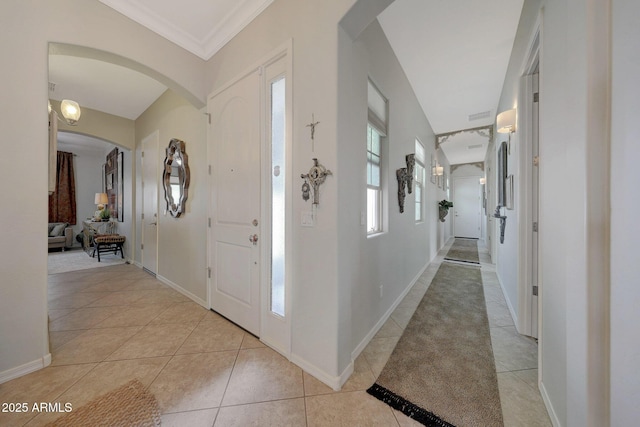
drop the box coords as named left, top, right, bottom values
left=453, top=177, right=481, bottom=239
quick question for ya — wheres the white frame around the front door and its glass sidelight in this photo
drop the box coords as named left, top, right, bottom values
left=206, top=39, right=294, bottom=359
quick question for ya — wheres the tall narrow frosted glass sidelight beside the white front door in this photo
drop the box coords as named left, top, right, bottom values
left=271, top=77, right=286, bottom=317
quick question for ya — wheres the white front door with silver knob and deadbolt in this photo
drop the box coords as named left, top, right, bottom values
left=209, top=70, right=262, bottom=335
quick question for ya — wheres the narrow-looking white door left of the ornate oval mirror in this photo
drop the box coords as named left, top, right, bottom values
left=141, top=131, right=160, bottom=274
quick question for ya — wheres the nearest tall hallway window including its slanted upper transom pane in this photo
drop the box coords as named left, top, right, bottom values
left=367, top=80, right=388, bottom=234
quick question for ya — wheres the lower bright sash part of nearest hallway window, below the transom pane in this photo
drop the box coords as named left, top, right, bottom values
left=367, top=125, right=382, bottom=234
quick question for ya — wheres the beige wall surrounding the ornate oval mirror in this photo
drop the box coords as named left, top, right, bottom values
left=135, top=90, right=209, bottom=306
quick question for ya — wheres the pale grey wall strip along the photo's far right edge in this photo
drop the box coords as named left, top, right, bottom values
left=610, top=0, right=640, bottom=426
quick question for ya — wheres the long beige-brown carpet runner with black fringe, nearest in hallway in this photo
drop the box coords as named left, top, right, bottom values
left=367, top=262, right=503, bottom=427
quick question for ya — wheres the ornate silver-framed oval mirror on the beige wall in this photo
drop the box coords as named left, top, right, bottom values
left=162, top=138, right=190, bottom=218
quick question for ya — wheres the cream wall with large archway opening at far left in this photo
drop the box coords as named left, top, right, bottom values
left=0, top=0, right=205, bottom=381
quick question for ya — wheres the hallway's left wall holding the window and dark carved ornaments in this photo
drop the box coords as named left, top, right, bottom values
left=337, top=21, right=444, bottom=370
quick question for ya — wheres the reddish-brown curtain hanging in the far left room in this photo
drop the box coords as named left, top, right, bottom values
left=49, top=151, right=76, bottom=224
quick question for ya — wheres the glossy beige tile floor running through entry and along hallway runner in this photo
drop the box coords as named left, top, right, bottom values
left=0, top=245, right=551, bottom=427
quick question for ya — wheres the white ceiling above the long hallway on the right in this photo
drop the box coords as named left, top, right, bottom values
left=378, top=0, right=523, bottom=164
